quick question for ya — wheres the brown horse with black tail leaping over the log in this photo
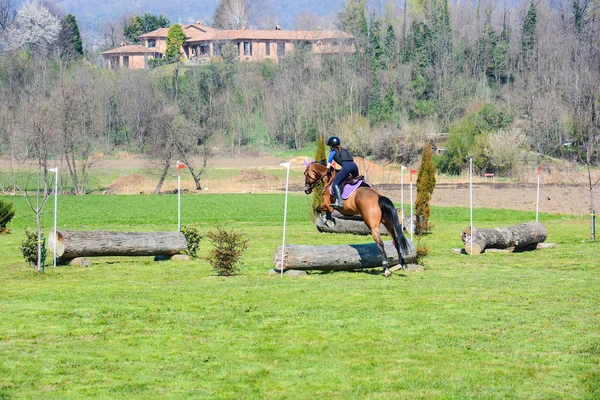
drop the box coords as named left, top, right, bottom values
left=304, top=162, right=408, bottom=276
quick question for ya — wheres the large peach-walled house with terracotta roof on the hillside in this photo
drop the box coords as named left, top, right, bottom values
left=102, top=22, right=356, bottom=69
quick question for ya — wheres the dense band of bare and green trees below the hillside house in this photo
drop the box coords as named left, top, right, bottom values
left=0, top=0, right=600, bottom=193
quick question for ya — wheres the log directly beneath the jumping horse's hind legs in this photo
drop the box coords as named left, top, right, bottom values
left=273, top=240, right=417, bottom=271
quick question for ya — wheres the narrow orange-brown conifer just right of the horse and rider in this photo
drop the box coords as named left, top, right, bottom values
left=415, top=144, right=435, bottom=235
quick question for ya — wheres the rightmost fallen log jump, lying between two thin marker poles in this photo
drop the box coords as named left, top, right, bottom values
left=461, top=222, right=548, bottom=254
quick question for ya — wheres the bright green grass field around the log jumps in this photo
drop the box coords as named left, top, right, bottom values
left=0, top=194, right=600, bottom=399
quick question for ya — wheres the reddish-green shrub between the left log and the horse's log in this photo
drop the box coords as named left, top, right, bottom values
left=208, top=228, right=248, bottom=276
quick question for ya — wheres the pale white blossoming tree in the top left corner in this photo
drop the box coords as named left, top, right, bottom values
left=4, top=1, right=61, bottom=52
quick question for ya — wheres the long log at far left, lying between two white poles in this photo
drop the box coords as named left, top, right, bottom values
left=48, top=231, right=187, bottom=258
